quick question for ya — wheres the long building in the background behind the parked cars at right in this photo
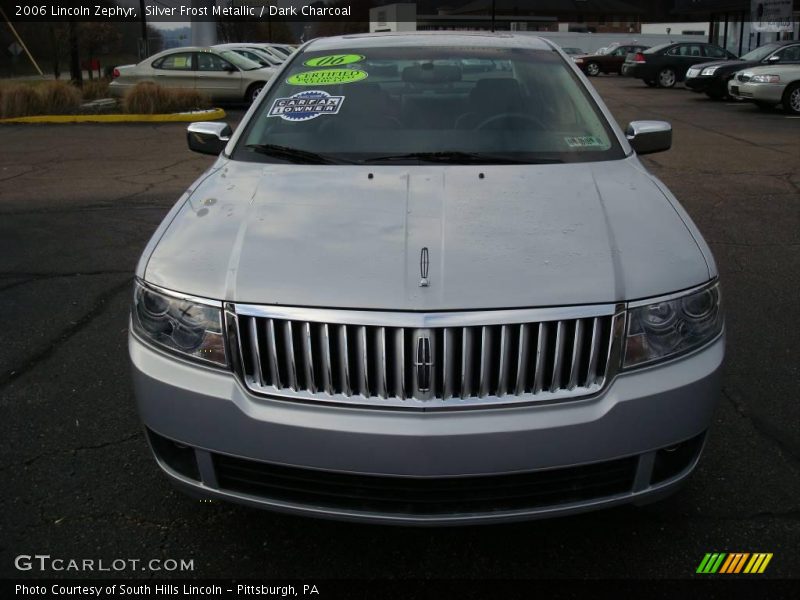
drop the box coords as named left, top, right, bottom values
left=370, top=0, right=800, bottom=55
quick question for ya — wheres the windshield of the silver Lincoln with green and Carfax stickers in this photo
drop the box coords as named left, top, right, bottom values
left=233, top=47, right=624, bottom=164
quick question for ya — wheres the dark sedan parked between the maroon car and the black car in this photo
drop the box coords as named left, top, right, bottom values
left=625, top=42, right=737, bottom=87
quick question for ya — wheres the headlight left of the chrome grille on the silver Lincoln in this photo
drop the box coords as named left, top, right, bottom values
left=131, top=280, right=228, bottom=366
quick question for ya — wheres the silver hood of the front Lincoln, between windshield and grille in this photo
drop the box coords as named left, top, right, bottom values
left=144, top=157, right=711, bottom=310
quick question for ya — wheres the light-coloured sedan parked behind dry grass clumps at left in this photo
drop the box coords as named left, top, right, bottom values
left=109, top=47, right=278, bottom=102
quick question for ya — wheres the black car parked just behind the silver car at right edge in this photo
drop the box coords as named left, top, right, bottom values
left=686, top=40, right=800, bottom=100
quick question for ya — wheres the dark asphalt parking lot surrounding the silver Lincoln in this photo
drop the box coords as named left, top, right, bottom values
left=0, top=76, right=800, bottom=579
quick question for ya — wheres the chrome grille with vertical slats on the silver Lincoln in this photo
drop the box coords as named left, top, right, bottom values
left=226, top=305, right=623, bottom=408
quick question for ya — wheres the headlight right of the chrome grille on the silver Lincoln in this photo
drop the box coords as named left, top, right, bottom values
left=623, top=283, right=723, bottom=367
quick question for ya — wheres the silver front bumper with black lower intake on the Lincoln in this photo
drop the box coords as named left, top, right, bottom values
left=129, top=336, right=724, bottom=524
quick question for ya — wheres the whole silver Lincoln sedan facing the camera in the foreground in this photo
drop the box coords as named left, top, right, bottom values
left=129, top=32, right=724, bottom=524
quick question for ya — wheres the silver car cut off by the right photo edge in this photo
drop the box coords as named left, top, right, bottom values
left=728, top=64, right=800, bottom=115
